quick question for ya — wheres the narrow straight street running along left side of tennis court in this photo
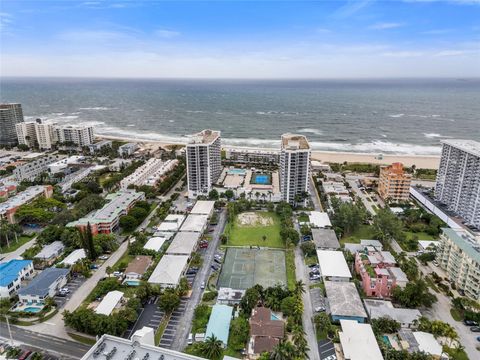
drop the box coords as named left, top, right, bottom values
left=171, top=209, right=227, bottom=351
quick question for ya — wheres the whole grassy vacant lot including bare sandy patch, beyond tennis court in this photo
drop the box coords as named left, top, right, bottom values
left=226, top=211, right=285, bottom=248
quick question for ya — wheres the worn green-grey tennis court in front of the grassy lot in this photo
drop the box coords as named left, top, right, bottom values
left=217, top=248, right=287, bottom=290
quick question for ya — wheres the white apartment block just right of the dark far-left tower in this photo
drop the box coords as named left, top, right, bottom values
left=15, top=119, right=57, bottom=150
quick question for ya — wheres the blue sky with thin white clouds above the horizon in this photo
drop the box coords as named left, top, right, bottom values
left=0, top=0, right=480, bottom=79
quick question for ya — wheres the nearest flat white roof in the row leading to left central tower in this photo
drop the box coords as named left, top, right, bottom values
left=148, top=255, right=188, bottom=286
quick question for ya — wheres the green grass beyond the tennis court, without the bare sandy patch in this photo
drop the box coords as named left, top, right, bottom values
left=226, top=212, right=285, bottom=248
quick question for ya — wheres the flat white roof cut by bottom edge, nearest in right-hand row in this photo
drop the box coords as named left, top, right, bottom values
left=339, top=320, right=383, bottom=360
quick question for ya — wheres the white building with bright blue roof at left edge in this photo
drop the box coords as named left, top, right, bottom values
left=0, top=259, right=33, bottom=299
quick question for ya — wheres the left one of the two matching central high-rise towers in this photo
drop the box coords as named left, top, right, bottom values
left=186, top=129, right=222, bottom=198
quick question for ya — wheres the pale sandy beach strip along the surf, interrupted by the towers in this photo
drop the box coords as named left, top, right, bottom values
left=95, top=134, right=440, bottom=169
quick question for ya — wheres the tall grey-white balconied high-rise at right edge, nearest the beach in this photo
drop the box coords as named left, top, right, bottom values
left=435, top=140, right=480, bottom=228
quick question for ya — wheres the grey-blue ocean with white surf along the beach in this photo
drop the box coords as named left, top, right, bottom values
left=0, top=78, right=480, bottom=155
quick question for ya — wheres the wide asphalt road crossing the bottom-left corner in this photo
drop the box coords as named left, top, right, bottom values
left=0, top=322, right=90, bottom=360
